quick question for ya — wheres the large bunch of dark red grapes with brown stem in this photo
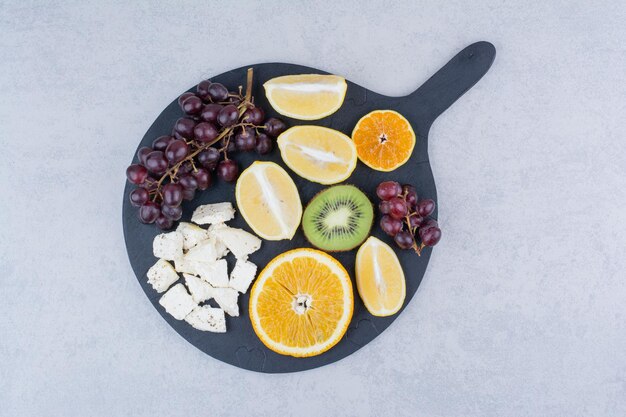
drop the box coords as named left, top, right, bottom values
left=126, top=69, right=287, bottom=229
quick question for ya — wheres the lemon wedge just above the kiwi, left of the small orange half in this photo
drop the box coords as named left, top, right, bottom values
left=278, top=126, right=357, bottom=184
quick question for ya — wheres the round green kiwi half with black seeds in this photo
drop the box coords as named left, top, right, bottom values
left=302, top=185, right=374, bottom=252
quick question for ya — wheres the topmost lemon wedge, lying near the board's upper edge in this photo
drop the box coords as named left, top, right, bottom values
left=263, top=74, right=348, bottom=120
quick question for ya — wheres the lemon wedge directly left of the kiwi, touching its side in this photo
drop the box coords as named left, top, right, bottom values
left=235, top=161, right=302, bottom=240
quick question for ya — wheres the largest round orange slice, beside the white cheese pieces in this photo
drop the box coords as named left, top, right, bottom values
left=249, top=248, right=354, bottom=357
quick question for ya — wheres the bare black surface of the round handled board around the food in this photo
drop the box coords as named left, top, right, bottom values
left=123, top=42, right=495, bottom=373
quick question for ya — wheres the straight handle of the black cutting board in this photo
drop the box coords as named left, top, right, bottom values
left=403, top=41, right=496, bottom=128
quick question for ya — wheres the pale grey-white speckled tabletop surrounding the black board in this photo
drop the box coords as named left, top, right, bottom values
left=0, top=0, right=626, bottom=417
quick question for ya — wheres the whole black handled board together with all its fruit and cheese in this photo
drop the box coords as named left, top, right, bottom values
left=123, top=42, right=495, bottom=373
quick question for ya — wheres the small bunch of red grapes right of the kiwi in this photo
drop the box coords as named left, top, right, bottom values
left=376, top=181, right=441, bottom=255
